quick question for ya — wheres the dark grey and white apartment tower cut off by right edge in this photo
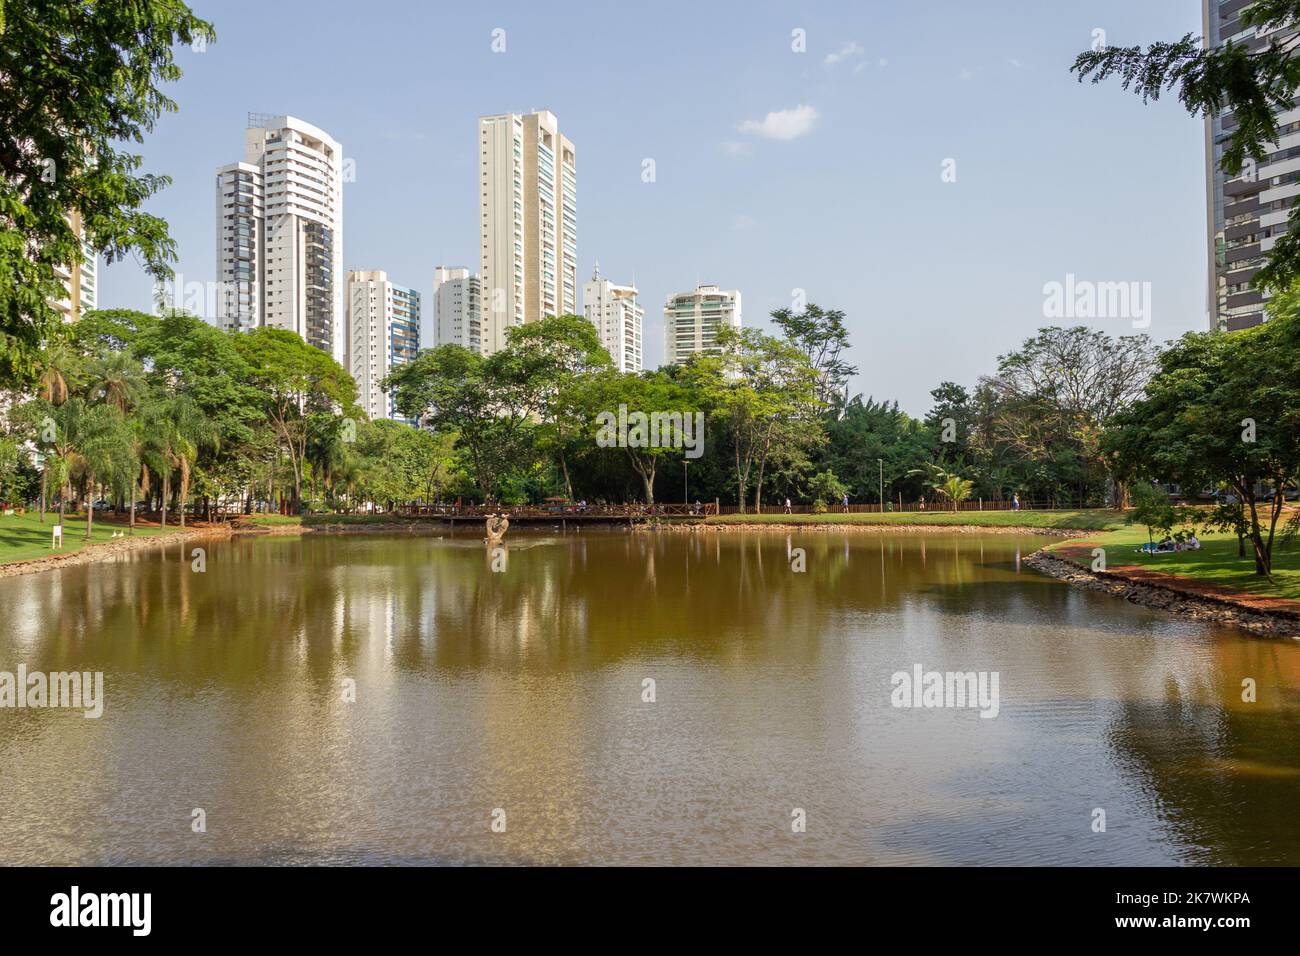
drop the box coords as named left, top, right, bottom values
left=1201, top=0, right=1300, bottom=332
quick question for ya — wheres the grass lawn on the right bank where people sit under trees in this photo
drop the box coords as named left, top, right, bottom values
left=1050, top=522, right=1300, bottom=601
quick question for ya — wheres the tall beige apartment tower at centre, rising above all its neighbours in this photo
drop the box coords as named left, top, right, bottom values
left=478, top=109, right=577, bottom=355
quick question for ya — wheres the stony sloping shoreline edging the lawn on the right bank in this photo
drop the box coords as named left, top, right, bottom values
left=1024, top=549, right=1300, bottom=639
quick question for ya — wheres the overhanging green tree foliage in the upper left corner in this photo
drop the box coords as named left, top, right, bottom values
left=0, top=0, right=215, bottom=386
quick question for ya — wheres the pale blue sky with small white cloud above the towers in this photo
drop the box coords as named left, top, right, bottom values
left=100, top=0, right=1206, bottom=415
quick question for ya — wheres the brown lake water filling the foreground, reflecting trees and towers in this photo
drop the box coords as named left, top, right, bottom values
left=0, top=531, right=1300, bottom=865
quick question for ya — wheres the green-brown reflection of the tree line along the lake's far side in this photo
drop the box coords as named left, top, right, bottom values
left=0, top=532, right=1066, bottom=682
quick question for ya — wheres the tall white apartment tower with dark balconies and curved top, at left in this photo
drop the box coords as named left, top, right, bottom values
left=217, top=113, right=345, bottom=362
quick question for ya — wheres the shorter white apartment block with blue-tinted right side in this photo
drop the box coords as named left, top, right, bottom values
left=346, top=271, right=420, bottom=424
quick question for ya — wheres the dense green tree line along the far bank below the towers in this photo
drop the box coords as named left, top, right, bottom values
left=0, top=306, right=1180, bottom=522
